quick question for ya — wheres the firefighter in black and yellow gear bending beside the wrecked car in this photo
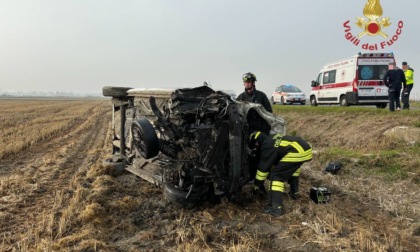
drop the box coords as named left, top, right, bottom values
left=248, top=131, right=312, bottom=216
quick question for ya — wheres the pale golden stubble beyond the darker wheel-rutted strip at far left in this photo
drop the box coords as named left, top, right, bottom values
left=0, top=100, right=104, bottom=158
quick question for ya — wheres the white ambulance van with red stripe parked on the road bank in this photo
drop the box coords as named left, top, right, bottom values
left=309, top=53, right=395, bottom=108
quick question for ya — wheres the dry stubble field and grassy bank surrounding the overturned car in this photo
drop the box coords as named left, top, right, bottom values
left=0, top=99, right=420, bottom=251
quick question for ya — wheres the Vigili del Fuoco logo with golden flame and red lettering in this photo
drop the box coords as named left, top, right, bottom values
left=343, top=0, right=404, bottom=51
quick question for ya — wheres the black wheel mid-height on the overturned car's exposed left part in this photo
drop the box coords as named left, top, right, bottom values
left=131, top=118, right=159, bottom=159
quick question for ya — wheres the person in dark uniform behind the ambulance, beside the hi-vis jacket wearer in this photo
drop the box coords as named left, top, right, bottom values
left=383, top=62, right=407, bottom=112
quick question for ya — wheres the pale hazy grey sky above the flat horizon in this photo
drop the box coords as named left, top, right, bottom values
left=0, top=0, right=420, bottom=99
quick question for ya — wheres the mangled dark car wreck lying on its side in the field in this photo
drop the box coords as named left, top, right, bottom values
left=102, top=86, right=286, bottom=203
